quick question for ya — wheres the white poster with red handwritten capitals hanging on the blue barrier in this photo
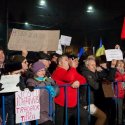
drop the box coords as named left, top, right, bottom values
left=15, top=89, right=40, bottom=123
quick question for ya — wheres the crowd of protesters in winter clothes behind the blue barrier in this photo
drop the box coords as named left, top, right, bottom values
left=0, top=45, right=125, bottom=125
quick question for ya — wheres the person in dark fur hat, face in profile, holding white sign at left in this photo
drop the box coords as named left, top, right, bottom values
left=0, top=55, right=28, bottom=125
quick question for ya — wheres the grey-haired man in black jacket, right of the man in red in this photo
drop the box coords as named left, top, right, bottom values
left=80, top=58, right=106, bottom=125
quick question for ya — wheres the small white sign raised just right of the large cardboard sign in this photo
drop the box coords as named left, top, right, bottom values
left=60, top=35, right=72, bottom=46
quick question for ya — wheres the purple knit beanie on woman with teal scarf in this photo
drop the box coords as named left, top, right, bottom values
left=32, top=61, right=45, bottom=73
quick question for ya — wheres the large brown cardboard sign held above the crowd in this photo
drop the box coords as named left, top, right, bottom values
left=8, top=29, right=60, bottom=51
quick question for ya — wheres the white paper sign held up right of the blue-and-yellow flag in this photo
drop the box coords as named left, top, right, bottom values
left=105, top=49, right=123, bottom=61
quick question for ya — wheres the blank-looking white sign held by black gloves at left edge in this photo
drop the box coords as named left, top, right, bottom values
left=0, top=74, right=20, bottom=93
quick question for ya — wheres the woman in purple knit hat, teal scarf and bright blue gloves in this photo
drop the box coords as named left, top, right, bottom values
left=27, top=61, right=58, bottom=125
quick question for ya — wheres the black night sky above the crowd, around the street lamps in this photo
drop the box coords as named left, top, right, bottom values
left=0, top=0, right=125, bottom=49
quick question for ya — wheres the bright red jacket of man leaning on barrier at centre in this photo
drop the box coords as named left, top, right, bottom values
left=52, top=67, right=86, bottom=107
